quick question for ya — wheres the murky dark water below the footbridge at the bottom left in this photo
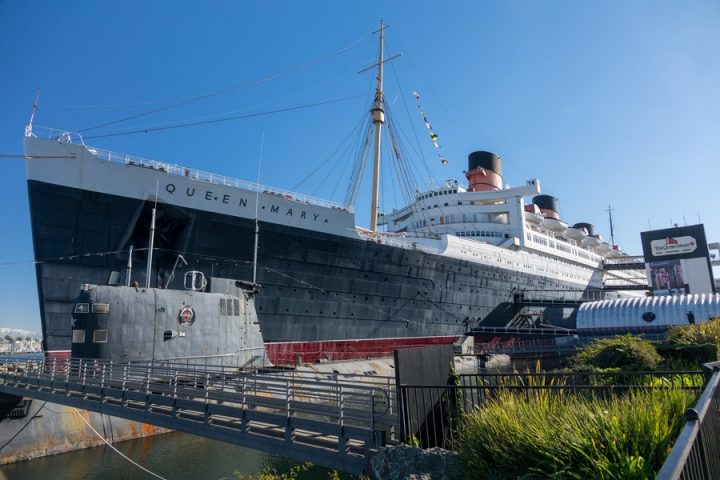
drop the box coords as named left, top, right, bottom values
left=0, top=432, right=351, bottom=480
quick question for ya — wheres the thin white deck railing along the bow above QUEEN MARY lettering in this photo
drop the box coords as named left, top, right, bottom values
left=26, top=126, right=352, bottom=212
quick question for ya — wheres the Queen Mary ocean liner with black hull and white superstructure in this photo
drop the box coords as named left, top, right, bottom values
left=24, top=22, right=636, bottom=363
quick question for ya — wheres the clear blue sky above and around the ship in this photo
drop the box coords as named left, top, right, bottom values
left=0, top=0, right=720, bottom=330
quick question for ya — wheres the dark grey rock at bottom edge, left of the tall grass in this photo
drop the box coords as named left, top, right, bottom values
left=370, top=445, right=456, bottom=480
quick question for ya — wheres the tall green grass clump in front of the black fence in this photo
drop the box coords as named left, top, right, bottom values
left=456, top=389, right=695, bottom=479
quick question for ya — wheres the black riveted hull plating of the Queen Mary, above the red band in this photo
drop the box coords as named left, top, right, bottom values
left=28, top=180, right=588, bottom=360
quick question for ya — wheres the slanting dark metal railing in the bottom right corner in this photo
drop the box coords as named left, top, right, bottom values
left=657, top=362, right=720, bottom=480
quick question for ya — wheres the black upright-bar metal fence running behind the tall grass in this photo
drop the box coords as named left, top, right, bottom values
left=398, top=371, right=704, bottom=450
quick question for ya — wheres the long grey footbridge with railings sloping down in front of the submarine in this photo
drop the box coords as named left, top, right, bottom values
left=0, top=359, right=398, bottom=474
